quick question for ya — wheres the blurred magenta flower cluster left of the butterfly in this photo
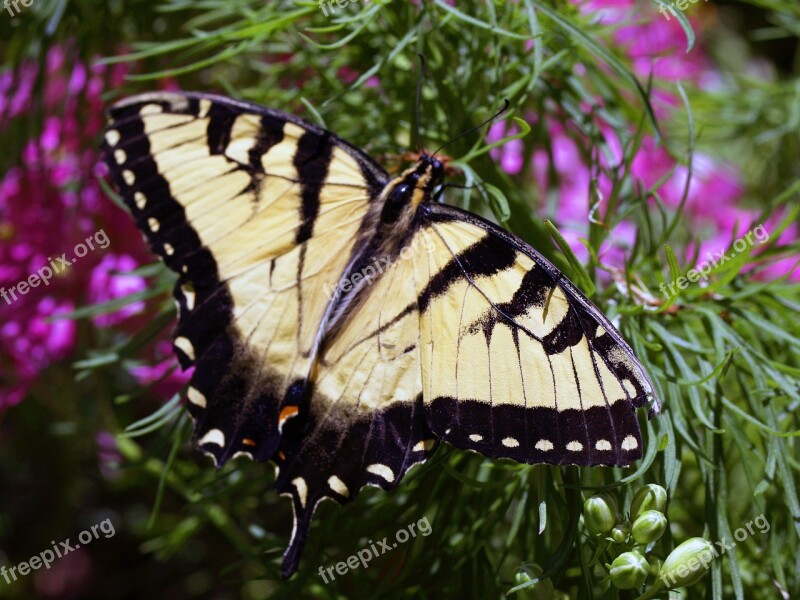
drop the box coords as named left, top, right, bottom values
left=0, top=46, right=146, bottom=413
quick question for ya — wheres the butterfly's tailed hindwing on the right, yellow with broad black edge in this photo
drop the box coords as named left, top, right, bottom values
left=276, top=233, right=435, bottom=577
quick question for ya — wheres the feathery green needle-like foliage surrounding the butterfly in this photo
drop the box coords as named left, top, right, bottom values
left=4, top=0, right=800, bottom=600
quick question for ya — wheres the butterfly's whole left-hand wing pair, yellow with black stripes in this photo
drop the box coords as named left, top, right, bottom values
left=104, top=92, right=387, bottom=464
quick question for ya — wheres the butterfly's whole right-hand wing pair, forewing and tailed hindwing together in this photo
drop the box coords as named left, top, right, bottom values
left=262, top=198, right=652, bottom=573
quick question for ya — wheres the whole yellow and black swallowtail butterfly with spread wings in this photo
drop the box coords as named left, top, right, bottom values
left=103, top=92, right=658, bottom=577
